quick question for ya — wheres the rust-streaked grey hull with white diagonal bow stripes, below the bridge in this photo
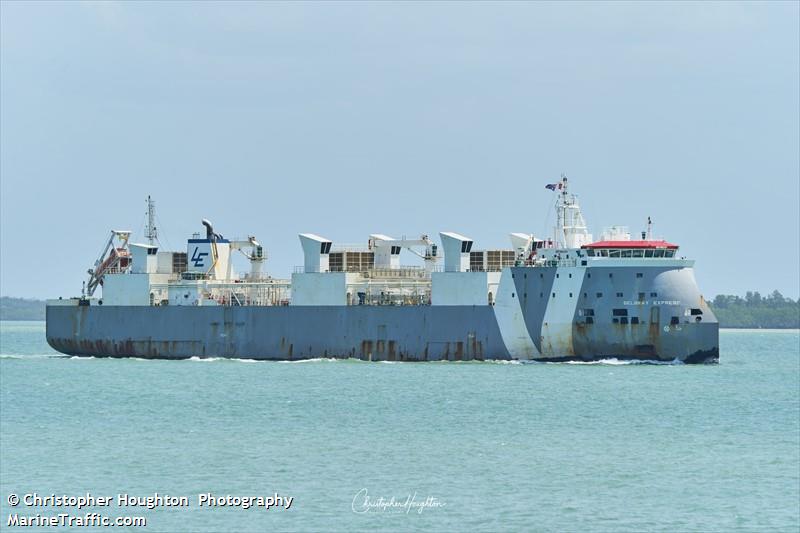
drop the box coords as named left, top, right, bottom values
left=42, top=266, right=719, bottom=363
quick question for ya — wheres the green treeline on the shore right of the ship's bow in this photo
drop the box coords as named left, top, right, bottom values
left=709, top=291, right=800, bottom=328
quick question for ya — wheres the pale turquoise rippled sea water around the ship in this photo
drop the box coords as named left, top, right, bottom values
left=0, top=322, right=800, bottom=532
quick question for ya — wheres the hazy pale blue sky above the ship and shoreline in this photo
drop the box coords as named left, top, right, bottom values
left=0, top=1, right=800, bottom=298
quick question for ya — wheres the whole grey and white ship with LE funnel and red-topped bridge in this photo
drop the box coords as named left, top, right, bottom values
left=47, top=176, right=719, bottom=363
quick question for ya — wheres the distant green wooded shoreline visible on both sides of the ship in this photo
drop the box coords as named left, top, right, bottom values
left=0, top=291, right=800, bottom=328
